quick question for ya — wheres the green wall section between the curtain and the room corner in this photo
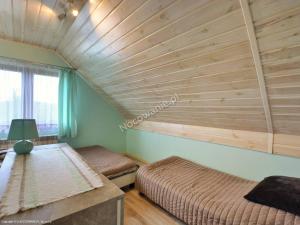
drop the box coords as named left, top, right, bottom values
left=62, top=74, right=126, bottom=152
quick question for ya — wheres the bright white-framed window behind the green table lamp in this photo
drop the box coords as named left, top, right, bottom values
left=0, top=69, right=59, bottom=139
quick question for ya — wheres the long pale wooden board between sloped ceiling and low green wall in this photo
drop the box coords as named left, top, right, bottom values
left=134, top=121, right=300, bottom=157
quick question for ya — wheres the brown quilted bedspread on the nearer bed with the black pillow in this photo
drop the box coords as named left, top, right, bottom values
left=136, top=156, right=300, bottom=225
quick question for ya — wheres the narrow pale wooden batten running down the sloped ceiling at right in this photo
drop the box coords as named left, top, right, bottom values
left=240, top=0, right=274, bottom=153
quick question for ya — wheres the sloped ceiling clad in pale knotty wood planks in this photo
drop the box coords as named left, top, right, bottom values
left=0, top=0, right=300, bottom=135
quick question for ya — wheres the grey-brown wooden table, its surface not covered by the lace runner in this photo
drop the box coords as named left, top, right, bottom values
left=0, top=145, right=124, bottom=225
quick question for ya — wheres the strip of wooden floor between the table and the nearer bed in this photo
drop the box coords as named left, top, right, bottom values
left=124, top=189, right=184, bottom=225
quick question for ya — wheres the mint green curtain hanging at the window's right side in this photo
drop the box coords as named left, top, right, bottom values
left=58, top=69, right=77, bottom=138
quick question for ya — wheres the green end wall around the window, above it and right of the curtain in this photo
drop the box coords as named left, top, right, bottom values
left=0, top=39, right=126, bottom=152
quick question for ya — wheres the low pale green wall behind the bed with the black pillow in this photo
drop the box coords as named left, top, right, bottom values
left=126, top=129, right=300, bottom=181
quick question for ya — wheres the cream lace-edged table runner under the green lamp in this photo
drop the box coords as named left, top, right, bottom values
left=0, top=144, right=103, bottom=218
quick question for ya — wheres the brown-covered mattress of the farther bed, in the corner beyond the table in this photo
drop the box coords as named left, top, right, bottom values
left=76, top=146, right=138, bottom=179
